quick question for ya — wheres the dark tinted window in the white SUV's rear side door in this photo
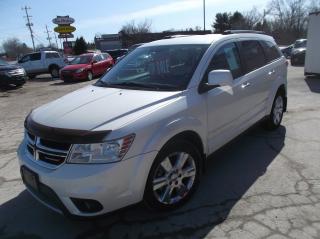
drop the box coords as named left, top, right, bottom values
left=239, top=41, right=266, bottom=72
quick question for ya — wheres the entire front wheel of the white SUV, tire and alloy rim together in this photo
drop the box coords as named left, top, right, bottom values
left=144, top=140, right=202, bottom=210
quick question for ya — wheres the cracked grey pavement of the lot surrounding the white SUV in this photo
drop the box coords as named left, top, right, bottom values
left=0, top=67, right=320, bottom=239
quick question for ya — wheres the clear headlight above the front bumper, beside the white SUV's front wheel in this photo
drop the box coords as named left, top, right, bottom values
left=67, top=134, right=135, bottom=163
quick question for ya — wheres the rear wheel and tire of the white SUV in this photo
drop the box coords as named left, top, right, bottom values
left=264, top=92, right=285, bottom=130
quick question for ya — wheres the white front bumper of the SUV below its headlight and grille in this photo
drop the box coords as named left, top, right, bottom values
left=18, top=142, right=157, bottom=217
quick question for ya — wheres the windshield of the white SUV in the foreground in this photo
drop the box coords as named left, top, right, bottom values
left=96, top=45, right=209, bottom=90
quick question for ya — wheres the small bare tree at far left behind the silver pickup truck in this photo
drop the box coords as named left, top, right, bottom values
left=2, top=38, right=32, bottom=58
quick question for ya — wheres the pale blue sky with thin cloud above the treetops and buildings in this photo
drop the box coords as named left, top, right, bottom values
left=0, top=0, right=267, bottom=46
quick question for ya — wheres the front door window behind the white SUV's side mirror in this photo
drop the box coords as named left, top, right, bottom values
left=205, top=43, right=242, bottom=81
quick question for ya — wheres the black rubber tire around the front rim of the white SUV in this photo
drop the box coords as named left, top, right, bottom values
left=144, top=140, right=202, bottom=210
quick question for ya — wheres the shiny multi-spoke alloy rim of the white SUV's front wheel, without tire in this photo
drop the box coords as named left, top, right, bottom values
left=153, top=152, right=197, bottom=205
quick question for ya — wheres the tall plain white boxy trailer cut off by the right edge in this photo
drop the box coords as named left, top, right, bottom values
left=304, top=12, right=320, bottom=77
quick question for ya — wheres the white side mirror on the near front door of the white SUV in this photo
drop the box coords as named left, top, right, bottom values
left=199, top=70, right=233, bottom=94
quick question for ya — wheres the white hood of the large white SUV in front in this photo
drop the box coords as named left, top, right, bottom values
left=30, top=86, right=181, bottom=130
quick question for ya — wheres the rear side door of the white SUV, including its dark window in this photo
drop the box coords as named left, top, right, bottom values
left=237, top=40, right=269, bottom=122
